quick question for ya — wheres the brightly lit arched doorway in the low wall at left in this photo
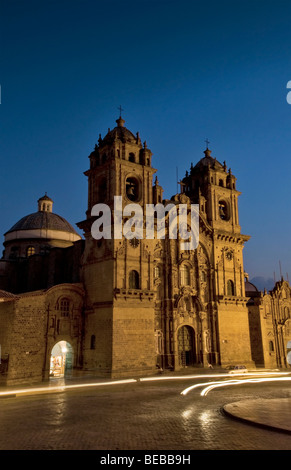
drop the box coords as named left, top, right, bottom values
left=50, top=341, right=73, bottom=377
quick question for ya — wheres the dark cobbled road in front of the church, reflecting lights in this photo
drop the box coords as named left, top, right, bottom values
left=0, top=379, right=291, bottom=450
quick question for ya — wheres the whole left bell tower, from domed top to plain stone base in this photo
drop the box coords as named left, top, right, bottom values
left=78, top=116, right=162, bottom=377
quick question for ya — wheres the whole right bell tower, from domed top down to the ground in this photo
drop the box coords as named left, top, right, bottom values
left=182, top=147, right=253, bottom=366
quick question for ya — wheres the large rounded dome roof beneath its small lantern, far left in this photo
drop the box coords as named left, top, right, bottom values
left=5, top=211, right=78, bottom=235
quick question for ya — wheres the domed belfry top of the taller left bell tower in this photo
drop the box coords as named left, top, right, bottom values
left=85, top=116, right=160, bottom=211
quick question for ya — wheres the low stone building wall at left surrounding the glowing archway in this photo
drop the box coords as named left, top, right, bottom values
left=0, top=284, right=84, bottom=384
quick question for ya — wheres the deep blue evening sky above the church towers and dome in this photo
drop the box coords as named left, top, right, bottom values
left=0, top=0, right=291, bottom=279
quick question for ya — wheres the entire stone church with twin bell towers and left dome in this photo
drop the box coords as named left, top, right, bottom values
left=0, top=117, right=291, bottom=384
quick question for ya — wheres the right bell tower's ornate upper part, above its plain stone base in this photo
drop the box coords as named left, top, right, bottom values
left=183, top=148, right=250, bottom=297
